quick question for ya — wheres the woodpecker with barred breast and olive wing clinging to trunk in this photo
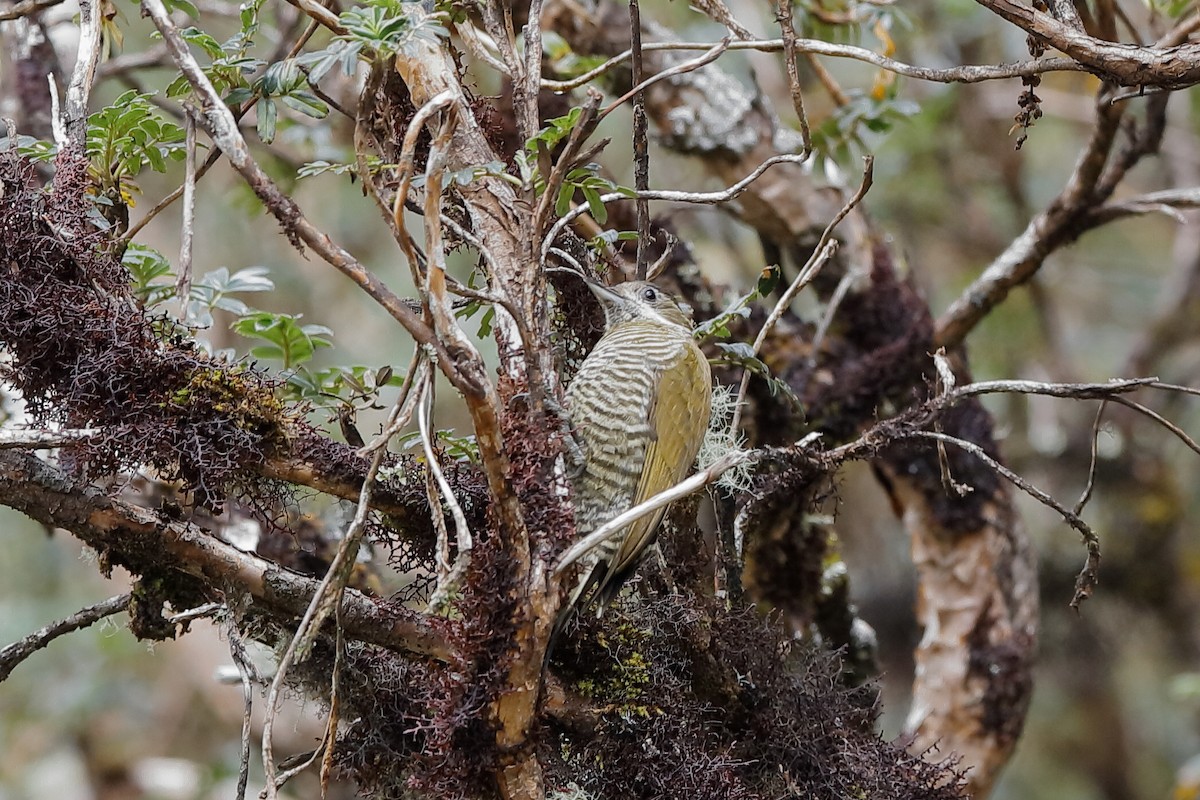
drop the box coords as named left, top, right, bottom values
left=552, top=281, right=713, bottom=640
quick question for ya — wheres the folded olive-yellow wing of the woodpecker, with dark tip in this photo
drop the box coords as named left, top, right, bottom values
left=599, top=341, right=713, bottom=594
